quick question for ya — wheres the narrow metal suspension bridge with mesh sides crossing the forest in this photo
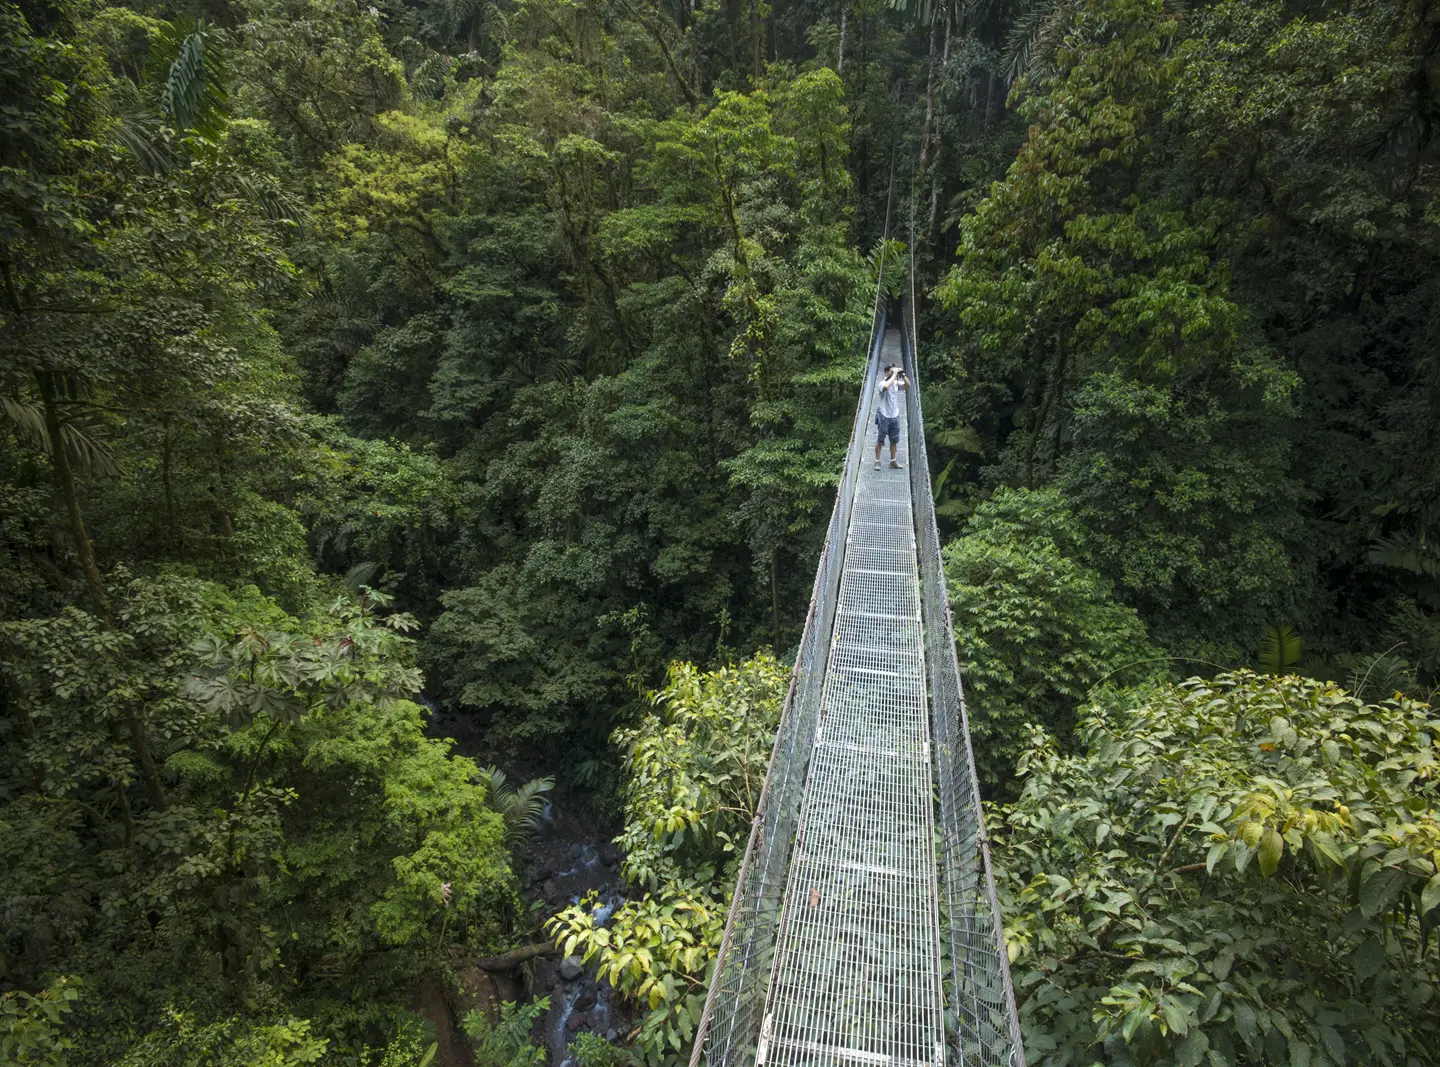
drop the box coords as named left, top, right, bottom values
left=690, top=256, right=1025, bottom=1067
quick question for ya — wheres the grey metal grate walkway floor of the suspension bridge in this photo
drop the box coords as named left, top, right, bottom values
left=756, top=330, right=945, bottom=1067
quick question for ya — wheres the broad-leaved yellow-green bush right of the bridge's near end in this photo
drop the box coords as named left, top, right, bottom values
left=996, top=674, right=1440, bottom=1067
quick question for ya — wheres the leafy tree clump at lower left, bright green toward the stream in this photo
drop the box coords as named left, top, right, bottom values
left=0, top=579, right=516, bottom=1063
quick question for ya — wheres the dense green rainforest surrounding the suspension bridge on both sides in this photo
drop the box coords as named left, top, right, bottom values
left=0, top=0, right=1440, bottom=1067
